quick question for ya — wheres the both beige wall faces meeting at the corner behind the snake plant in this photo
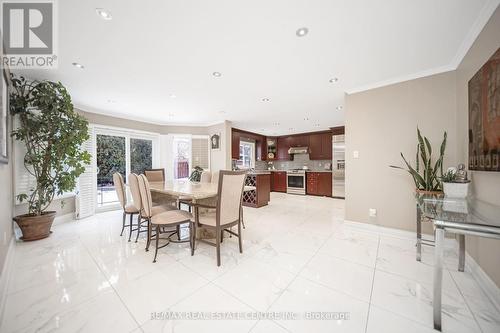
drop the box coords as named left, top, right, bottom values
left=346, top=8, right=500, bottom=286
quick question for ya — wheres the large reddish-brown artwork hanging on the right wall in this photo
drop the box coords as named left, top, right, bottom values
left=469, top=48, right=500, bottom=171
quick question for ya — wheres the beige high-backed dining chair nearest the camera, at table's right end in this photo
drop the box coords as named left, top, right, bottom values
left=186, top=170, right=246, bottom=266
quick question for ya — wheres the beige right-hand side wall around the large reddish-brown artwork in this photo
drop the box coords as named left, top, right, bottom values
left=456, top=8, right=500, bottom=286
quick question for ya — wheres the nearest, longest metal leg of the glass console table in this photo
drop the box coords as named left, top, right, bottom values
left=433, top=227, right=444, bottom=331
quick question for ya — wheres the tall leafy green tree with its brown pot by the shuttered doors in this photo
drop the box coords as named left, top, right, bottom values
left=10, top=75, right=90, bottom=241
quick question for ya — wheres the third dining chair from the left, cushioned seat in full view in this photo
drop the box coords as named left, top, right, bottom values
left=138, top=175, right=192, bottom=262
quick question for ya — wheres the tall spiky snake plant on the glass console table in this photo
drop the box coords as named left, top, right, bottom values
left=391, top=127, right=447, bottom=191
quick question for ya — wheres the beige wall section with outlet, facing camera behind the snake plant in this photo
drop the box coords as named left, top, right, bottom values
left=346, top=72, right=457, bottom=231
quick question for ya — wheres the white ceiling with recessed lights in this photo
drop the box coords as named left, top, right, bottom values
left=15, top=0, right=499, bottom=135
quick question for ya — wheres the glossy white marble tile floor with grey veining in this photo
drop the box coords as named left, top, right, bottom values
left=0, top=193, right=500, bottom=333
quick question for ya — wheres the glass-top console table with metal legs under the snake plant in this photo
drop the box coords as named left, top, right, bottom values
left=416, top=194, right=500, bottom=330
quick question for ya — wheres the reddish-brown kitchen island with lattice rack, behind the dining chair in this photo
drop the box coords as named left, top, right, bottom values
left=243, top=171, right=271, bottom=208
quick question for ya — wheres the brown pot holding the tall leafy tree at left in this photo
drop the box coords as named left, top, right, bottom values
left=14, top=212, right=56, bottom=241
